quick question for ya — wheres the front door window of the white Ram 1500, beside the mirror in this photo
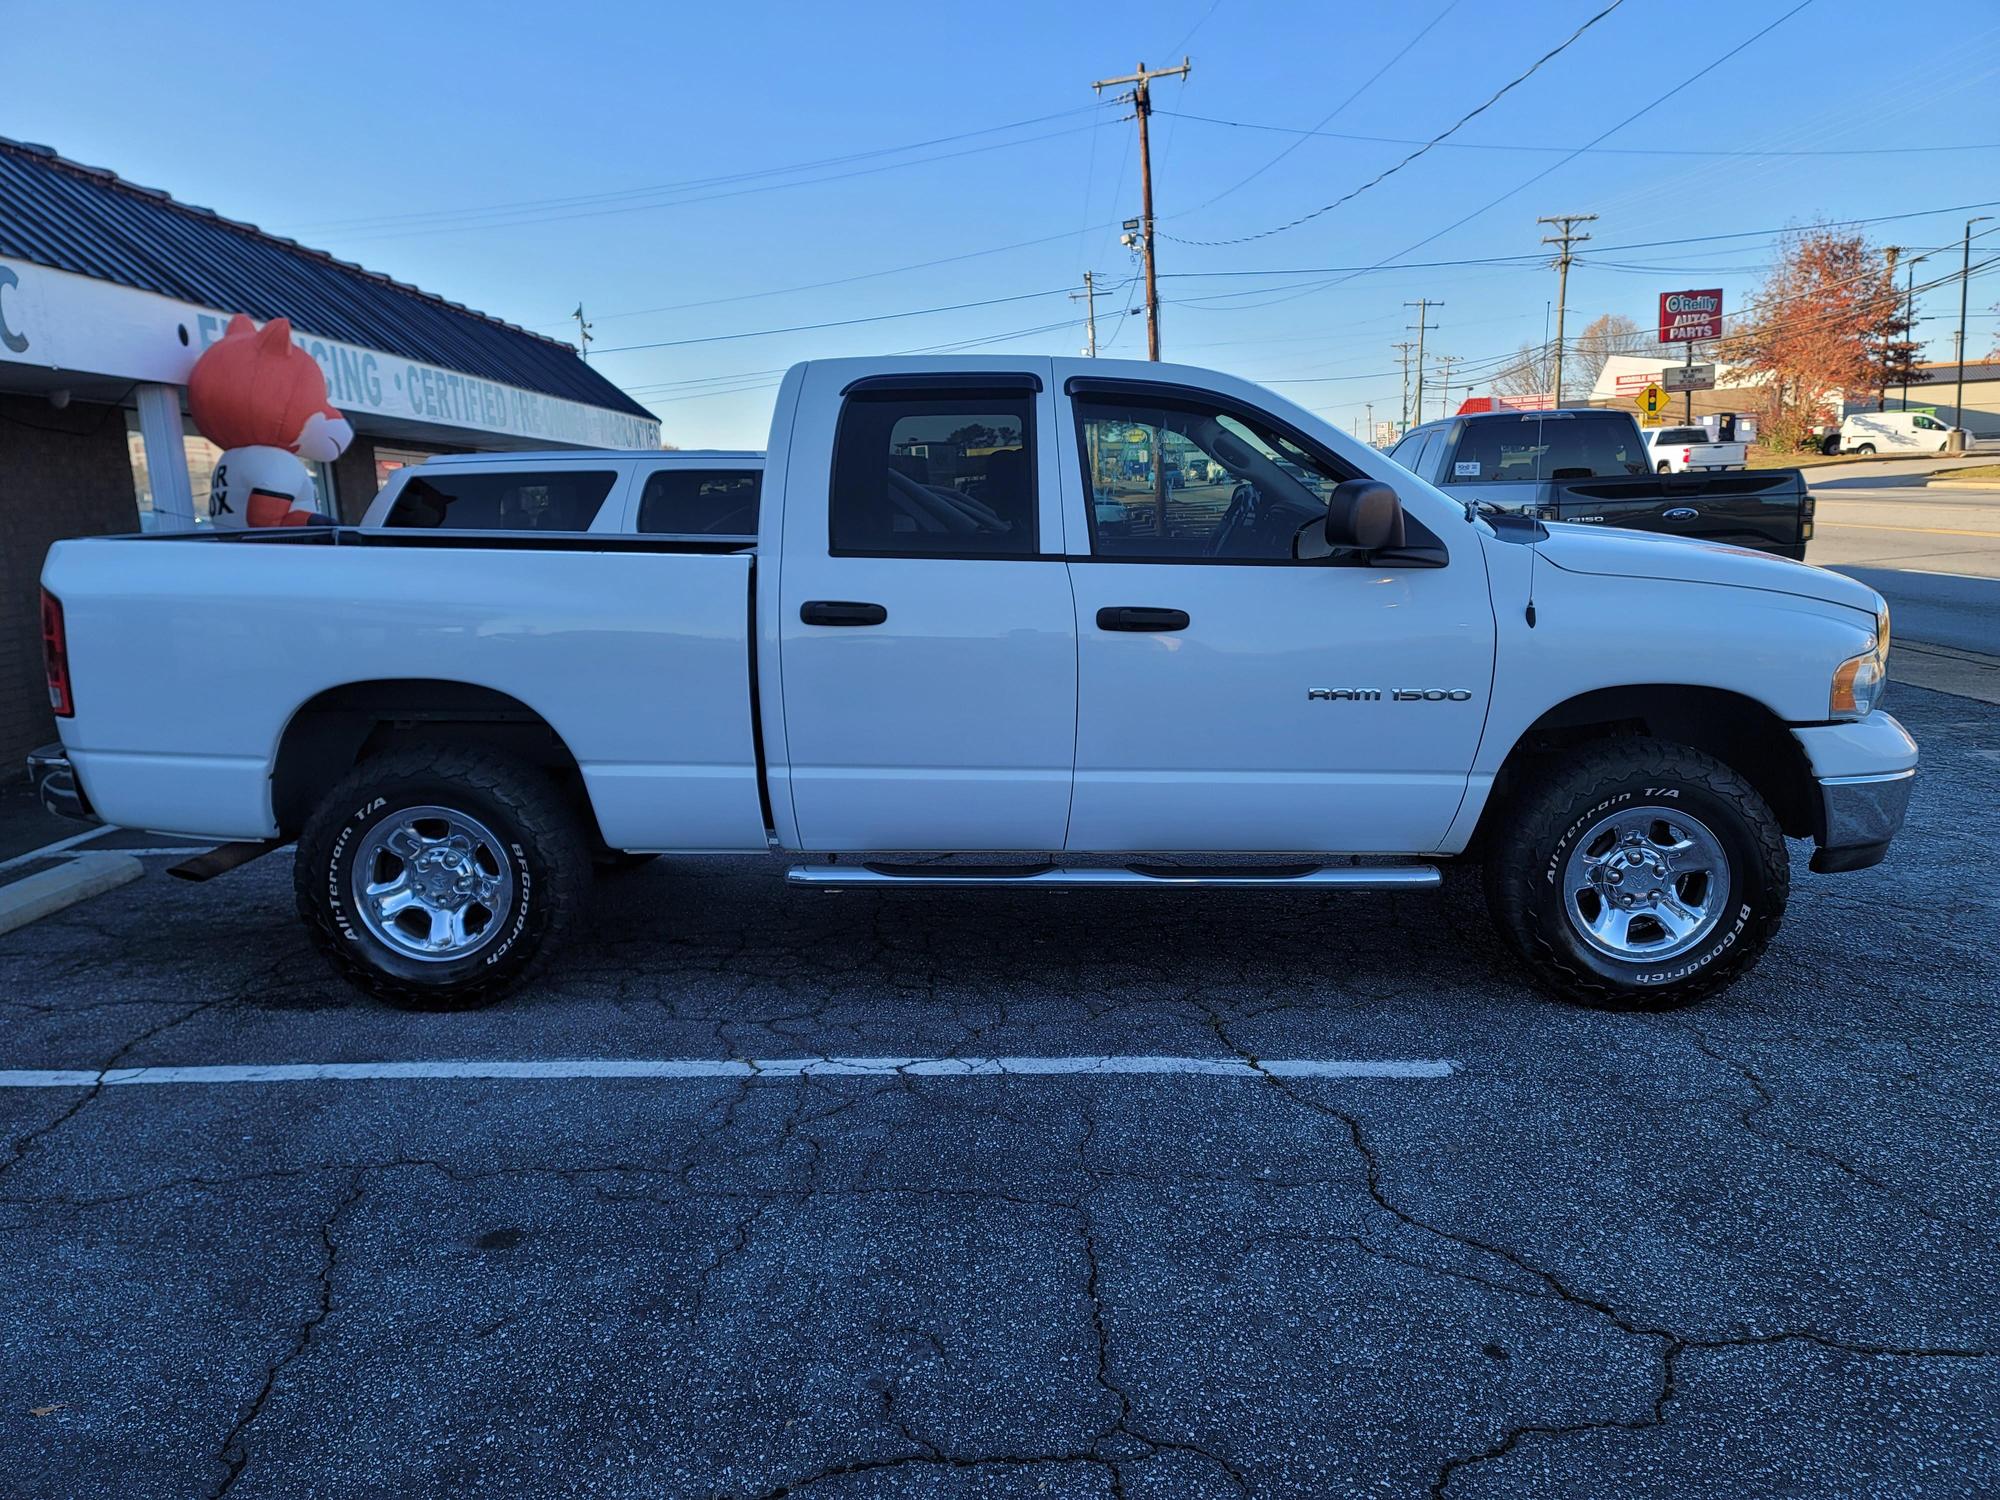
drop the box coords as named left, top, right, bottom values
left=1076, top=396, right=1344, bottom=560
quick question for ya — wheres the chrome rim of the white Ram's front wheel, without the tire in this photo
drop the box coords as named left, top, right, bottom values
left=1562, top=806, right=1730, bottom=964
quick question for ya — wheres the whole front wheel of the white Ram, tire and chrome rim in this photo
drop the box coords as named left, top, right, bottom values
left=1486, top=738, right=1792, bottom=1010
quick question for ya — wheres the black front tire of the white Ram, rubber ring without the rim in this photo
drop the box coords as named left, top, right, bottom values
left=1528, top=772, right=1782, bottom=1002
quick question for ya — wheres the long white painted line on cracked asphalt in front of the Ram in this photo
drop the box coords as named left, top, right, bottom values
left=0, top=1056, right=1458, bottom=1088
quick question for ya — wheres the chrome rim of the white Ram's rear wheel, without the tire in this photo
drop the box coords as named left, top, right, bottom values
left=350, top=806, right=514, bottom=964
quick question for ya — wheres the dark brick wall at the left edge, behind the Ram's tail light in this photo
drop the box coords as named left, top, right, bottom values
left=0, top=396, right=138, bottom=764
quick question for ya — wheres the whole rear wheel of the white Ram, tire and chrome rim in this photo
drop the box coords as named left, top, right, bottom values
left=294, top=744, right=590, bottom=1010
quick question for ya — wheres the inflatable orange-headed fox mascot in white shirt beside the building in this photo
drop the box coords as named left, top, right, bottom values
left=188, top=312, right=354, bottom=528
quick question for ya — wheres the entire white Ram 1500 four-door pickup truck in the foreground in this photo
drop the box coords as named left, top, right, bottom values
left=27, top=356, right=1916, bottom=1008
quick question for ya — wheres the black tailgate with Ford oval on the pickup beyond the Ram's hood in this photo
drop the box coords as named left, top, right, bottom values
left=1542, top=468, right=1812, bottom=558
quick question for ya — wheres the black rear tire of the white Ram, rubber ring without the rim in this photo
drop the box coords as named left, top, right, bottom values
left=310, top=780, right=548, bottom=998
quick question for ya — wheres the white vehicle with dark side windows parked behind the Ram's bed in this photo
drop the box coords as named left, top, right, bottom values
left=362, top=448, right=764, bottom=542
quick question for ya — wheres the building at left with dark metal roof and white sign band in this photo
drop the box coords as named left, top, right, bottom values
left=0, top=138, right=660, bottom=764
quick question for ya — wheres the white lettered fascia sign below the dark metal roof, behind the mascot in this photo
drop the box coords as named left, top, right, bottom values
left=0, top=260, right=660, bottom=448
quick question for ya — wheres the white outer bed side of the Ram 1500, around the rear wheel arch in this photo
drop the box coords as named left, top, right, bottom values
left=44, top=526, right=766, bottom=850
